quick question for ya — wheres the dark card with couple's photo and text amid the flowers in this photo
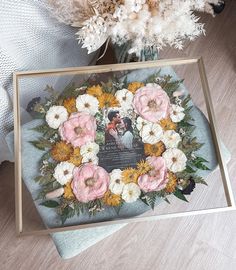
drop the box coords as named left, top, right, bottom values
left=99, top=109, right=144, bottom=172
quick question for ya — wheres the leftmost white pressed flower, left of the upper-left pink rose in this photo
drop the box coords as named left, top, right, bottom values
left=46, top=106, right=68, bottom=129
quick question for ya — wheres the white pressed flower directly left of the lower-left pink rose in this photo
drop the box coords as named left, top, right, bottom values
left=53, top=161, right=75, bottom=185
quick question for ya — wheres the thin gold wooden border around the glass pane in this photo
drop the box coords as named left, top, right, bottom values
left=13, top=57, right=235, bottom=235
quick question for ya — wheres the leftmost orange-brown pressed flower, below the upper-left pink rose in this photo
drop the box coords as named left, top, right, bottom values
left=51, top=141, right=73, bottom=161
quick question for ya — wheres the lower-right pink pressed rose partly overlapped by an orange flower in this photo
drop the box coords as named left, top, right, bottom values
left=138, top=157, right=168, bottom=192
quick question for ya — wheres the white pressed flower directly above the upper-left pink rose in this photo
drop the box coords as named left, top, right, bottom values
left=76, top=94, right=99, bottom=115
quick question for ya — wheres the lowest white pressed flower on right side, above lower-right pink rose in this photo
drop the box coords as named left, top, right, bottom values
left=162, top=148, right=187, bottom=173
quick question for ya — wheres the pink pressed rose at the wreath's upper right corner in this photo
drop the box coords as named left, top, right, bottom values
left=133, top=85, right=171, bottom=123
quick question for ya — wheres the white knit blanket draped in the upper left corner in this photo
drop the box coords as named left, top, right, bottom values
left=0, top=0, right=96, bottom=163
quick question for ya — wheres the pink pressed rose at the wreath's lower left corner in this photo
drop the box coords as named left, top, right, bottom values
left=71, top=163, right=109, bottom=203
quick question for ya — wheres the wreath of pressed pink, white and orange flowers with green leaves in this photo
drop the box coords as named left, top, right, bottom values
left=30, top=72, right=209, bottom=223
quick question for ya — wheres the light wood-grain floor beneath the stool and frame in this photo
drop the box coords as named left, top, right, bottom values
left=0, top=0, right=236, bottom=270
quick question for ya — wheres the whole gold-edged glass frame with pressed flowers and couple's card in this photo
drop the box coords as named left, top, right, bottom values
left=12, top=58, right=235, bottom=235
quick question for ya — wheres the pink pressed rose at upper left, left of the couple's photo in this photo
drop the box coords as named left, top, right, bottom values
left=59, top=112, right=97, bottom=147
